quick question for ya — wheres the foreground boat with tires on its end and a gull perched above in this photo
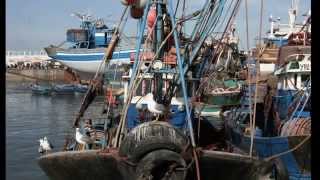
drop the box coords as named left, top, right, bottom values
left=39, top=0, right=298, bottom=180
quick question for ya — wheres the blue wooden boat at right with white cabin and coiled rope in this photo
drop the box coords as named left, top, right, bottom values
left=225, top=44, right=311, bottom=180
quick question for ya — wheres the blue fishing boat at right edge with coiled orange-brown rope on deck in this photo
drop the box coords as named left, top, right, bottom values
left=224, top=2, right=311, bottom=179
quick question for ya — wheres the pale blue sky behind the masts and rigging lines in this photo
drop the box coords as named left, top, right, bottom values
left=6, top=0, right=311, bottom=51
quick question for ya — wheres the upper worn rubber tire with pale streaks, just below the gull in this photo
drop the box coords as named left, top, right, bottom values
left=119, top=121, right=189, bottom=162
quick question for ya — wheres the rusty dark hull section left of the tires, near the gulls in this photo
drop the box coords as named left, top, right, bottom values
left=39, top=150, right=135, bottom=180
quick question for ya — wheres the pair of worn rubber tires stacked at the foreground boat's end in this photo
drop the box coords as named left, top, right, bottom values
left=119, top=121, right=189, bottom=180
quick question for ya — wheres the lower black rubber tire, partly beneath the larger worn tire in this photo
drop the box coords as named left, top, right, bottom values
left=136, top=149, right=187, bottom=180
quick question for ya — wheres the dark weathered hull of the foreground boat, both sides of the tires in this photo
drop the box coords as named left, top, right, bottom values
left=38, top=150, right=271, bottom=180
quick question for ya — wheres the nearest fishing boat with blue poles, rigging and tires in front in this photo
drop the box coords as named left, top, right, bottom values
left=39, top=0, right=296, bottom=180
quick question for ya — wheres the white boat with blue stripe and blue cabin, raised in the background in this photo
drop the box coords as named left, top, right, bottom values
left=44, top=13, right=135, bottom=73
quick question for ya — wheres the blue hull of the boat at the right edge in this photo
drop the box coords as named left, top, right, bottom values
left=230, top=131, right=311, bottom=180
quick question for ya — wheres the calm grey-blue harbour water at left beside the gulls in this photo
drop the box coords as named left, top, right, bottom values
left=6, top=84, right=105, bottom=180
